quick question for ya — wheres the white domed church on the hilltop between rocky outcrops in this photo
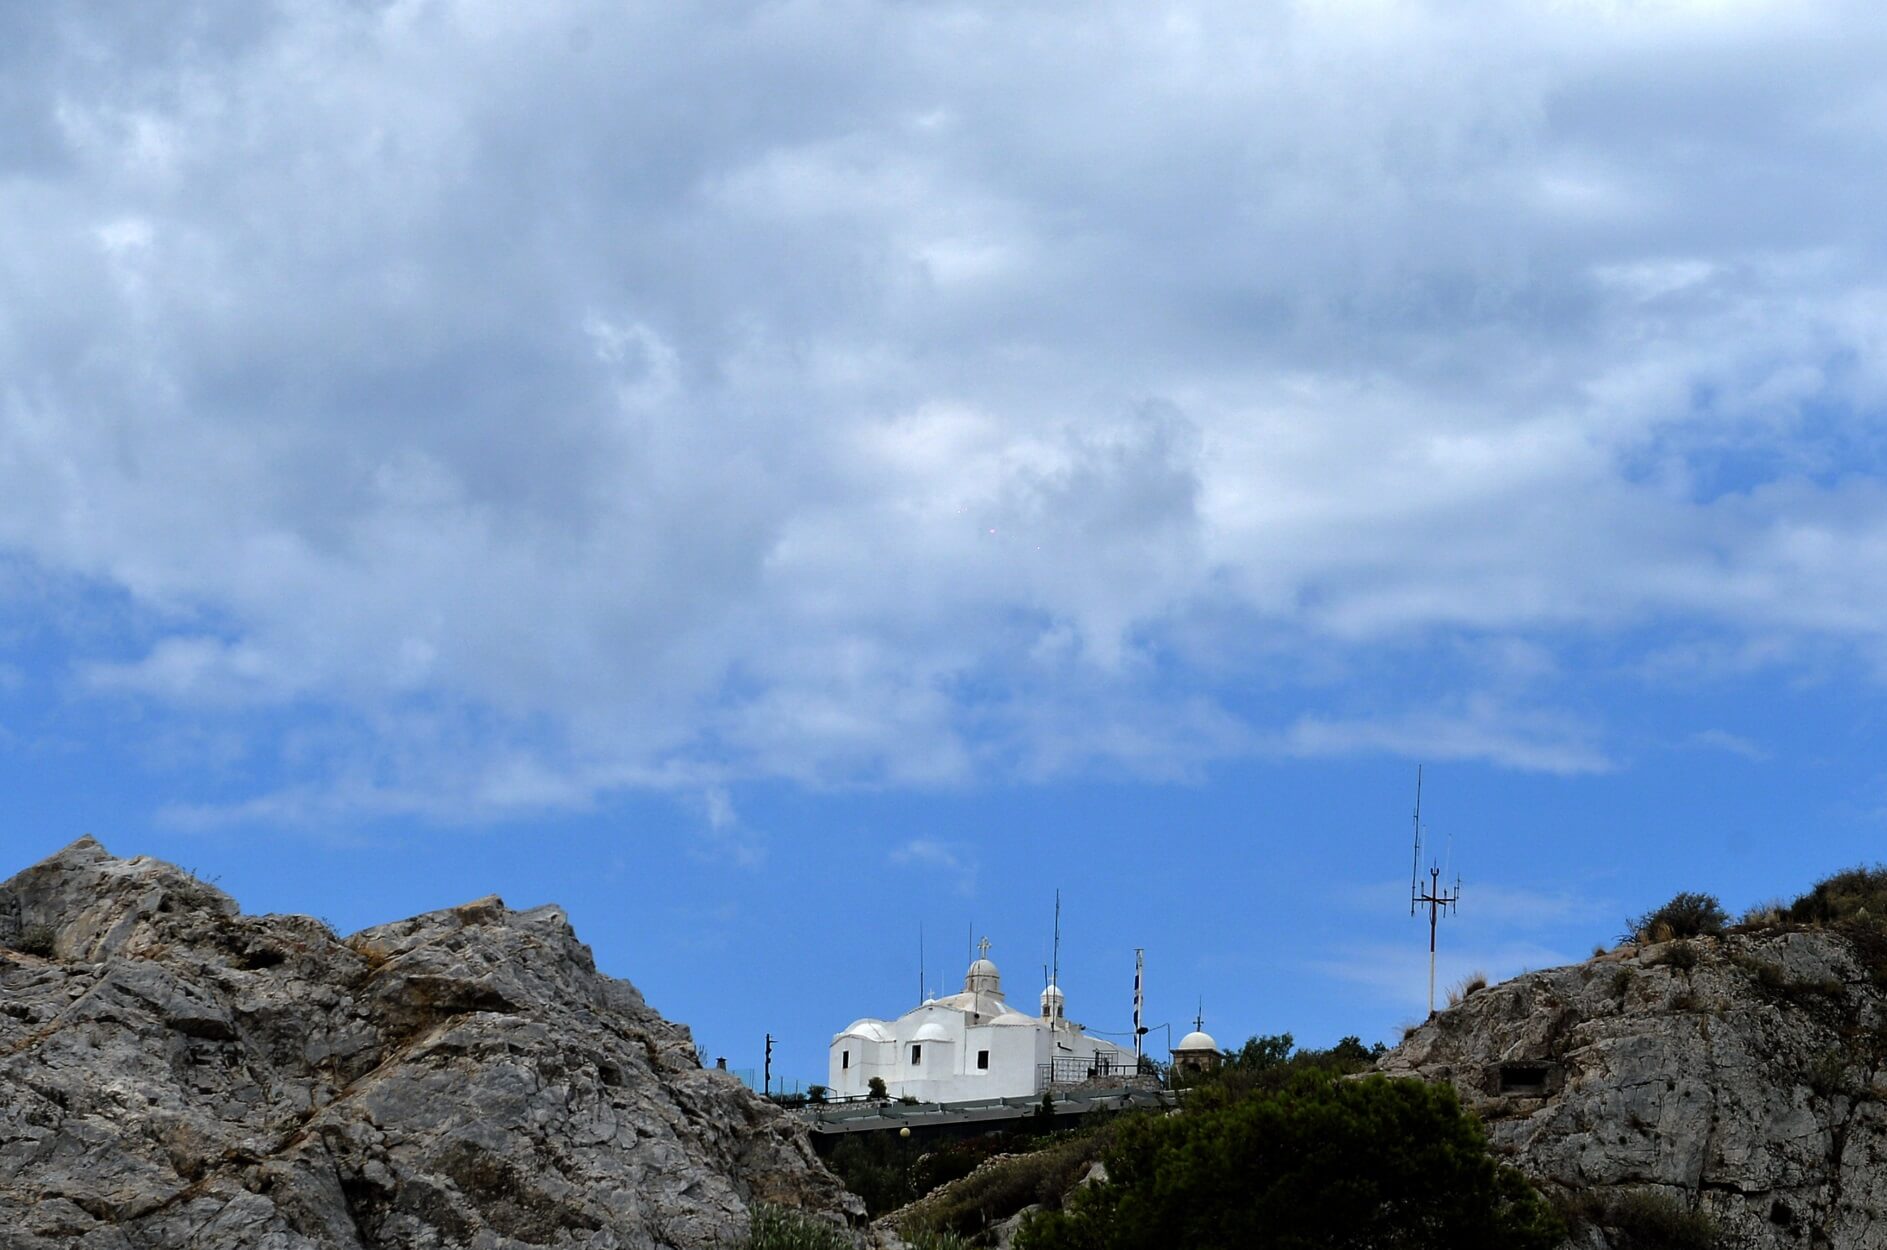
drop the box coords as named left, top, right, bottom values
left=827, top=938, right=1136, bottom=1103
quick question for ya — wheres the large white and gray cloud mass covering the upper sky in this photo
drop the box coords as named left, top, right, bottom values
left=0, top=0, right=1887, bottom=811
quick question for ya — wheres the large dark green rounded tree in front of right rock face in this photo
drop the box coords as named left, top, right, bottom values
left=1017, top=1069, right=1564, bottom=1250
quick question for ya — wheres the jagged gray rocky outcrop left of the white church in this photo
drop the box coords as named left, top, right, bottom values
left=0, top=838, right=862, bottom=1250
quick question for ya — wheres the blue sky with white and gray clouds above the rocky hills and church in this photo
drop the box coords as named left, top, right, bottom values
left=0, top=0, right=1887, bottom=1082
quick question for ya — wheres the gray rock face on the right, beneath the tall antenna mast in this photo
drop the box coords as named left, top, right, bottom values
left=1381, top=929, right=1887, bottom=1250
